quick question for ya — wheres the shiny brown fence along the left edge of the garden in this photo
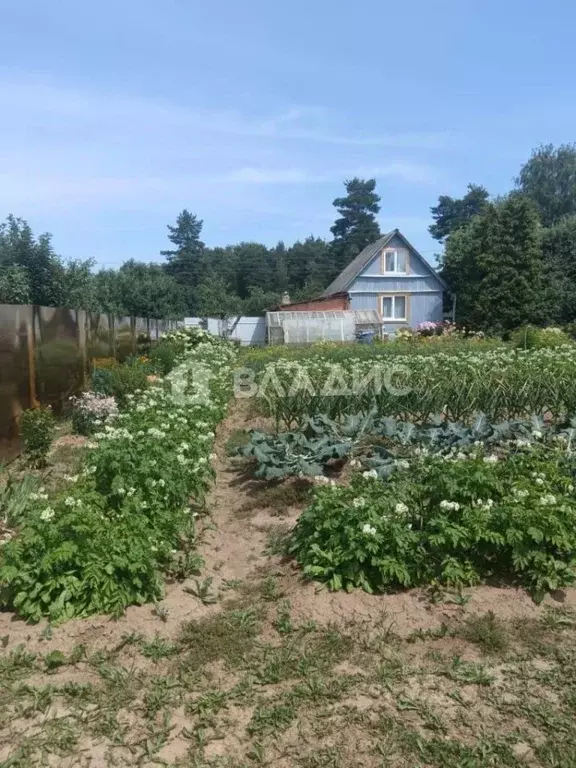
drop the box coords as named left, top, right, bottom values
left=0, top=304, right=177, bottom=460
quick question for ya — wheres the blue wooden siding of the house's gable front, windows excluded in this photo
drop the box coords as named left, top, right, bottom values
left=348, top=237, right=444, bottom=334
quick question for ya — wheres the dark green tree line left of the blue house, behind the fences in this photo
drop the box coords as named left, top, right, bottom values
left=0, top=178, right=380, bottom=318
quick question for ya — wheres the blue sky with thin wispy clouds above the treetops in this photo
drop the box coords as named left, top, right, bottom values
left=0, top=0, right=576, bottom=266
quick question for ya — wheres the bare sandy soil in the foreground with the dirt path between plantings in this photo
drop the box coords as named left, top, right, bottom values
left=0, top=403, right=576, bottom=768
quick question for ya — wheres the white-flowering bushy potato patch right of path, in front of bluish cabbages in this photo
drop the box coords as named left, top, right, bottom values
left=289, top=447, right=576, bottom=597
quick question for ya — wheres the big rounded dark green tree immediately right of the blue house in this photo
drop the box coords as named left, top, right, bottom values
left=442, top=195, right=544, bottom=332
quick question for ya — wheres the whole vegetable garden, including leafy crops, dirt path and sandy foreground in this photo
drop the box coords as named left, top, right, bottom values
left=0, top=331, right=576, bottom=768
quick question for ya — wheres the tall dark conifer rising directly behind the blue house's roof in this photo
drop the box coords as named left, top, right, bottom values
left=329, top=178, right=380, bottom=279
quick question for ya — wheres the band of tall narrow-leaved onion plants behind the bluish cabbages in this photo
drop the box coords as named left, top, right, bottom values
left=255, top=345, right=576, bottom=429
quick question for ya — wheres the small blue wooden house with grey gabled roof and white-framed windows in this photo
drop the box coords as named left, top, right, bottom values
left=322, top=229, right=448, bottom=334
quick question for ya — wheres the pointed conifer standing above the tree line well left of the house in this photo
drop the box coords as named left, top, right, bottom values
left=160, top=208, right=204, bottom=313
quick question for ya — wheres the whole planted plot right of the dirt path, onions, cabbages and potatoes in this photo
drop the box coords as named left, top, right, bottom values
left=235, top=345, right=576, bottom=599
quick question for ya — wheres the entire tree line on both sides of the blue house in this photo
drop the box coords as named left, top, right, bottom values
left=0, top=144, right=576, bottom=332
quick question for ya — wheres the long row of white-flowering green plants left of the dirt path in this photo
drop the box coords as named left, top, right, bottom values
left=0, top=332, right=235, bottom=622
